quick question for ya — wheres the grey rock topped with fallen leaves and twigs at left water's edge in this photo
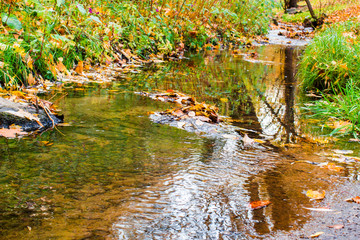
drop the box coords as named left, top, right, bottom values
left=0, top=97, right=63, bottom=132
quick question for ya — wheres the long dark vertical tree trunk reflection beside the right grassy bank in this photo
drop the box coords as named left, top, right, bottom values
left=284, top=48, right=295, bottom=142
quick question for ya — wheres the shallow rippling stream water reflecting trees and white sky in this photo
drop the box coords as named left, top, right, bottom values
left=0, top=45, right=360, bottom=239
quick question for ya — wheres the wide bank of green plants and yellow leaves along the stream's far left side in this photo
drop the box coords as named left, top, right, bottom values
left=0, top=0, right=276, bottom=87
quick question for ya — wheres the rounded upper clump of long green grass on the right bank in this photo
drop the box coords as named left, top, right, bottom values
left=298, top=21, right=360, bottom=92
